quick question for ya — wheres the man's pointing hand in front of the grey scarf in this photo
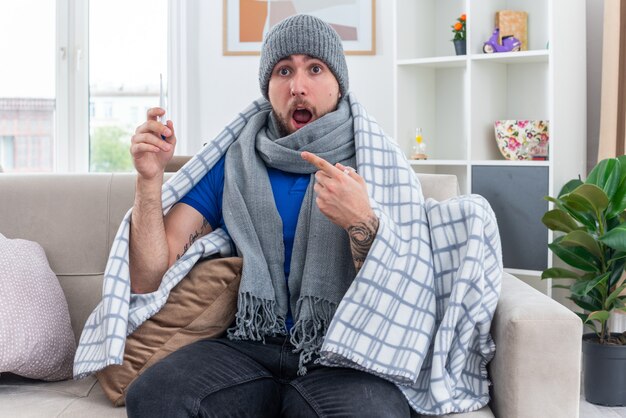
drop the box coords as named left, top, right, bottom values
left=302, top=151, right=376, bottom=229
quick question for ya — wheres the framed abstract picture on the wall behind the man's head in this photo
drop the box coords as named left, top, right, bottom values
left=223, top=0, right=376, bottom=55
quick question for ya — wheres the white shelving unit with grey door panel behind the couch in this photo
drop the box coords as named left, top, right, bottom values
left=394, top=0, right=586, bottom=293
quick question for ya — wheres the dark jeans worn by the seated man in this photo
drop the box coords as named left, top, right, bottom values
left=126, top=337, right=410, bottom=418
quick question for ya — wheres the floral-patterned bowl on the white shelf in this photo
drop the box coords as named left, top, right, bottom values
left=494, top=120, right=550, bottom=160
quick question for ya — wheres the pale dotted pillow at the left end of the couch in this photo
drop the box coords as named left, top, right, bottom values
left=0, top=234, right=76, bottom=380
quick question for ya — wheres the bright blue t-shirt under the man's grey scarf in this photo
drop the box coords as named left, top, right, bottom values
left=180, top=157, right=311, bottom=331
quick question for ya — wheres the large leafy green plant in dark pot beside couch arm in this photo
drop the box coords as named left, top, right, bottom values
left=541, top=156, right=626, bottom=406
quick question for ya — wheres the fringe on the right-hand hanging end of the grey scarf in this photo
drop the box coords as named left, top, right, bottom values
left=290, top=296, right=337, bottom=376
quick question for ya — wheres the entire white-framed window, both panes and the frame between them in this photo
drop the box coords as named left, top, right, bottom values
left=0, top=0, right=169, bottom=172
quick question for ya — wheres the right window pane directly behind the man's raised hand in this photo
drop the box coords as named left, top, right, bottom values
left=89, top=0, right=167, bottom=171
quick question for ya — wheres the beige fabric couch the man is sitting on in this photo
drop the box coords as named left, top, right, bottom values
left=0, top=173, right=582, bottom=418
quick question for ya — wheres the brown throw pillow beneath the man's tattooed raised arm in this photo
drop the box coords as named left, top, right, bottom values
left=96, top=257, right=242, bottom=406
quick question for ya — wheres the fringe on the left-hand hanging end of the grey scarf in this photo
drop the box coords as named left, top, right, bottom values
left=227, top=292, right=285, bottom=341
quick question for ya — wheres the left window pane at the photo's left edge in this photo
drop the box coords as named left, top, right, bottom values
left=0, top=0, right=56, bottom=172
